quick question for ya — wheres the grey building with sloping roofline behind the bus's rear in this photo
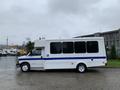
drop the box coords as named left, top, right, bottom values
left=75, top=29, right=120, bottom=57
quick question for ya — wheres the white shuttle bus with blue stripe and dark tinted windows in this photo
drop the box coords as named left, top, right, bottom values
left=18, top=37, right=107, bottom=72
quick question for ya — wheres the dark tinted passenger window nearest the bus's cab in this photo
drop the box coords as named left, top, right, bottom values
left=50, top=42, right=62, bottom=54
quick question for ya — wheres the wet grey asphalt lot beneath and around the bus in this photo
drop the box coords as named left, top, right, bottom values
left=0, top=57, right=120, bottom=90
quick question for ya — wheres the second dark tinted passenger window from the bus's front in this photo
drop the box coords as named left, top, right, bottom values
left=63, top=42, right=74, bottom=53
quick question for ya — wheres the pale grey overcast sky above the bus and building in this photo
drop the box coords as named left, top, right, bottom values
left=0, top=0, right=120, bottom=44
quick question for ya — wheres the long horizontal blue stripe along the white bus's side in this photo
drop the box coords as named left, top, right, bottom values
left=19, top=56, right=106, bottom=60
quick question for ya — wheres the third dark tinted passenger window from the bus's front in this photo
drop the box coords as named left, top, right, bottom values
left=75, top=42, right=86, bottom=53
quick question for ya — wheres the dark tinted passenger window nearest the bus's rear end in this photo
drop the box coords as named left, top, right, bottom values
left=87, top=41, right=98, bottom=53
